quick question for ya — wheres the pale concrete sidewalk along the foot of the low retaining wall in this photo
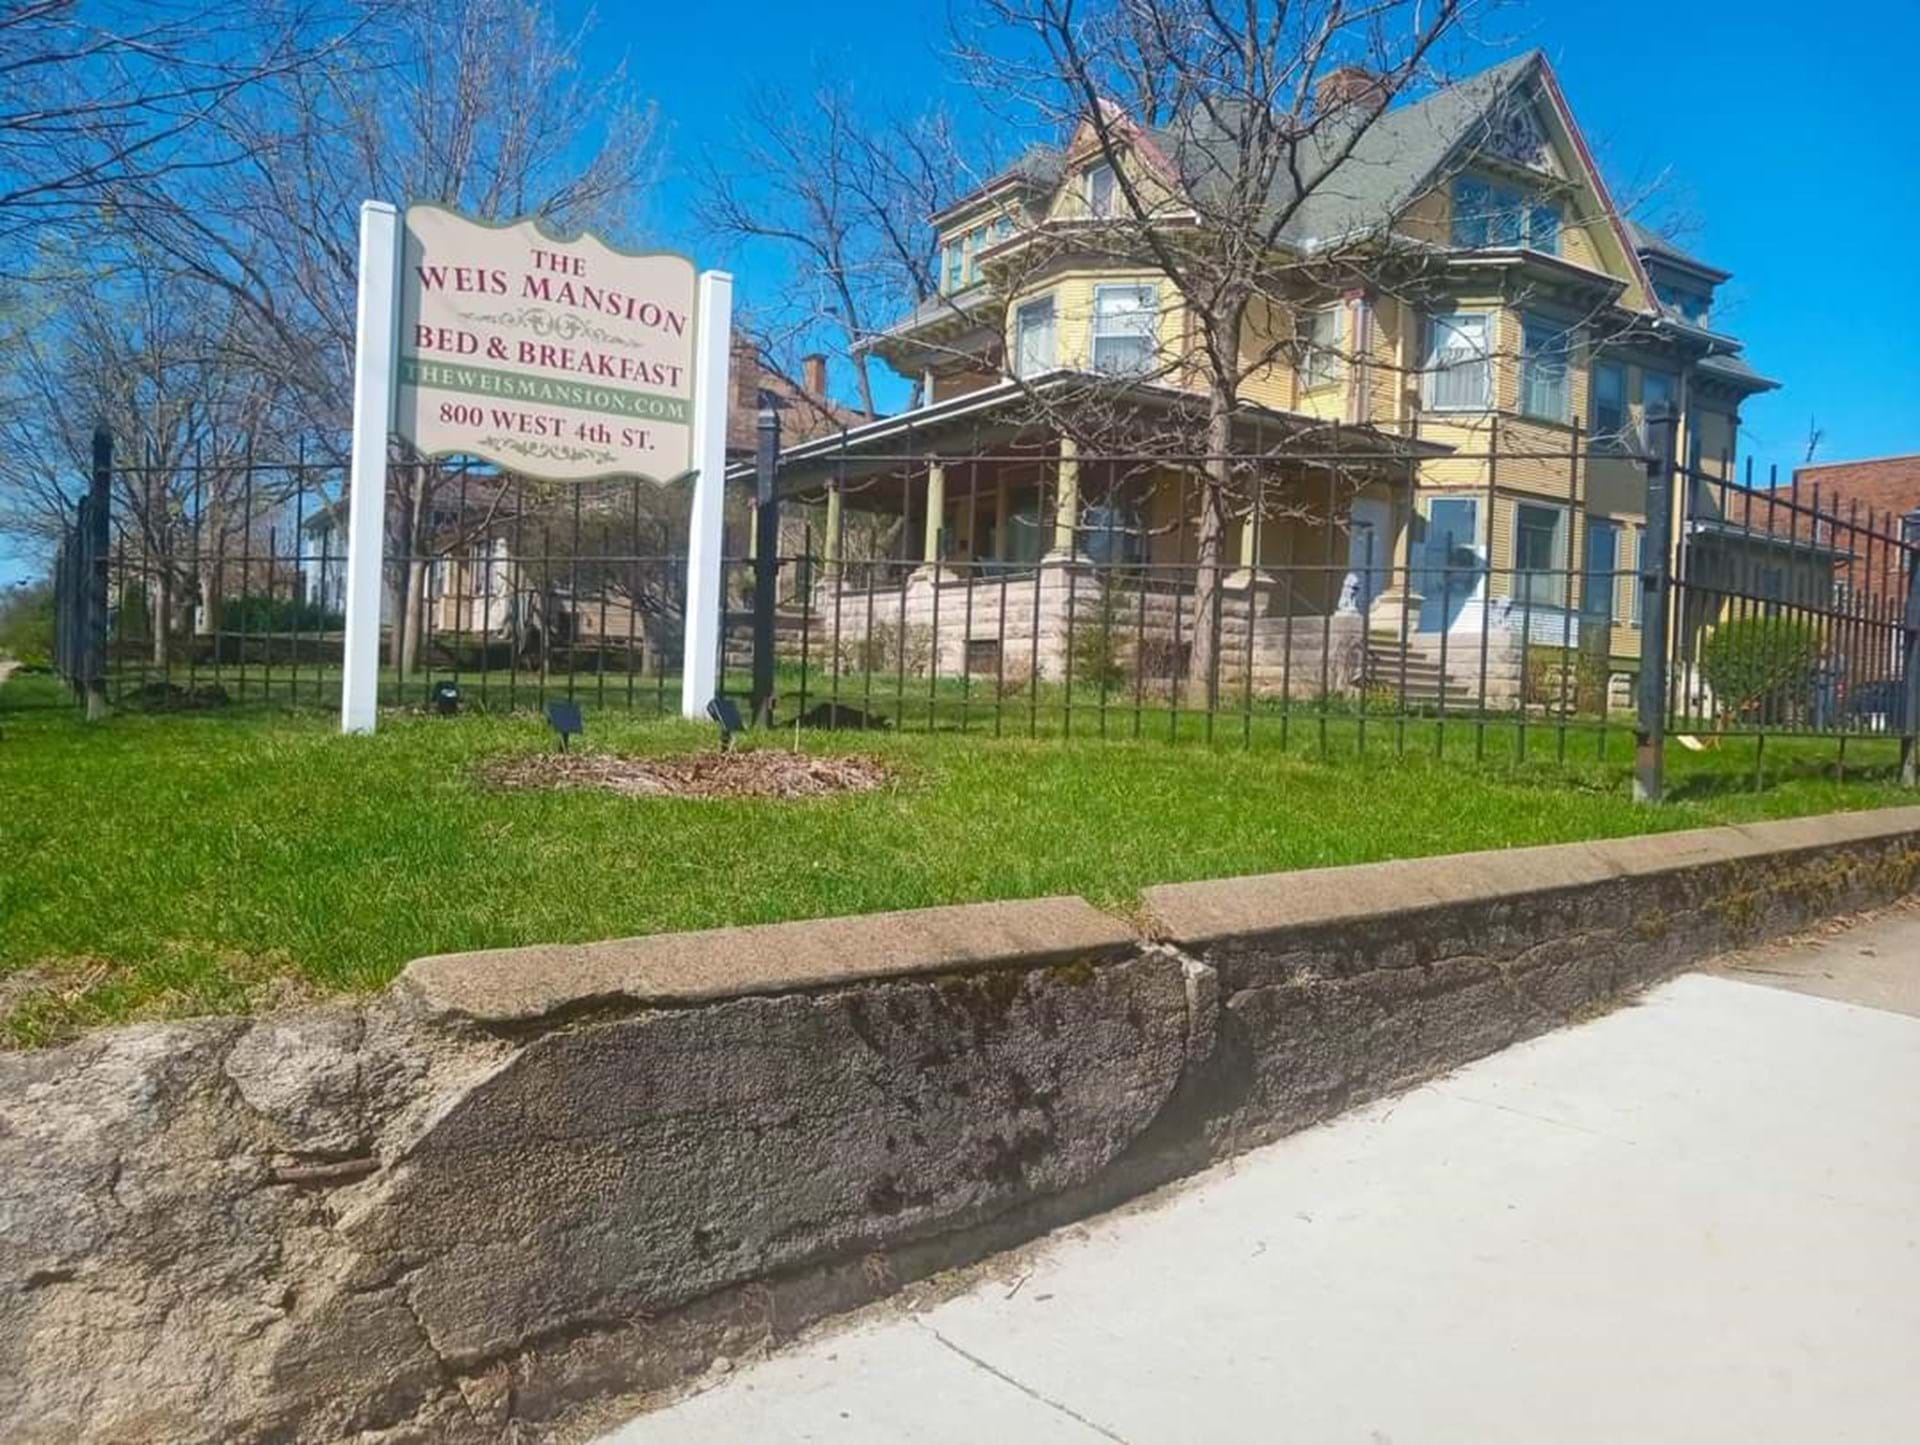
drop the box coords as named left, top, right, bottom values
left=607, top=912, right=1920, bottom=1445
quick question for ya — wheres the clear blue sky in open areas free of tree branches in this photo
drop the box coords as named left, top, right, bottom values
left=0, top=0, right=1920, bottom=585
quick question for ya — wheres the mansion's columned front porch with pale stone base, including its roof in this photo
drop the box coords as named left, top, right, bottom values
left=748, top=374, right=1443, bottom=699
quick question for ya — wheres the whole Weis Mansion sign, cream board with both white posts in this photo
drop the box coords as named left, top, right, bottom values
left=340, top=201, right=733, bottom=733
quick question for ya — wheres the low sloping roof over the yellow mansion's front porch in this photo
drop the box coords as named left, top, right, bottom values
left=728, top=370, right=1452, bottom=499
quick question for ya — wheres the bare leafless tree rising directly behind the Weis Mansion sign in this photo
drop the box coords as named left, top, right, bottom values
left=0, top=0, right=653, bottom=668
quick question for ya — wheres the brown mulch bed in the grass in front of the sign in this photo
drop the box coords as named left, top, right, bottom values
left=480, top=748, right=893, bottom=798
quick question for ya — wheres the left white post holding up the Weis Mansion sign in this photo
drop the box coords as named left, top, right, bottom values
left=340, top=201, right=399, bottom=733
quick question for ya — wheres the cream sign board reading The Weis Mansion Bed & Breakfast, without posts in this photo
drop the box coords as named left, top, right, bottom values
left=394, top=205, right=695, bottom=482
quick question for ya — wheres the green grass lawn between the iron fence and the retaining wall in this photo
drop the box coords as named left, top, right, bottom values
left=0, top=663, right=1908, bottom=1046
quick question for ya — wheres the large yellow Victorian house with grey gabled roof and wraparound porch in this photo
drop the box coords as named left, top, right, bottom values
left=756, top=52, right=1774, bottom=700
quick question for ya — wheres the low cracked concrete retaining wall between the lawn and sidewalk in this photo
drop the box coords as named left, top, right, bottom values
left=11, top=810, right=1920, bottom=1441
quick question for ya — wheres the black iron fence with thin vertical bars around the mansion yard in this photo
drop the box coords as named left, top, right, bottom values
left=41, top=414, right=1920, bottom=793
